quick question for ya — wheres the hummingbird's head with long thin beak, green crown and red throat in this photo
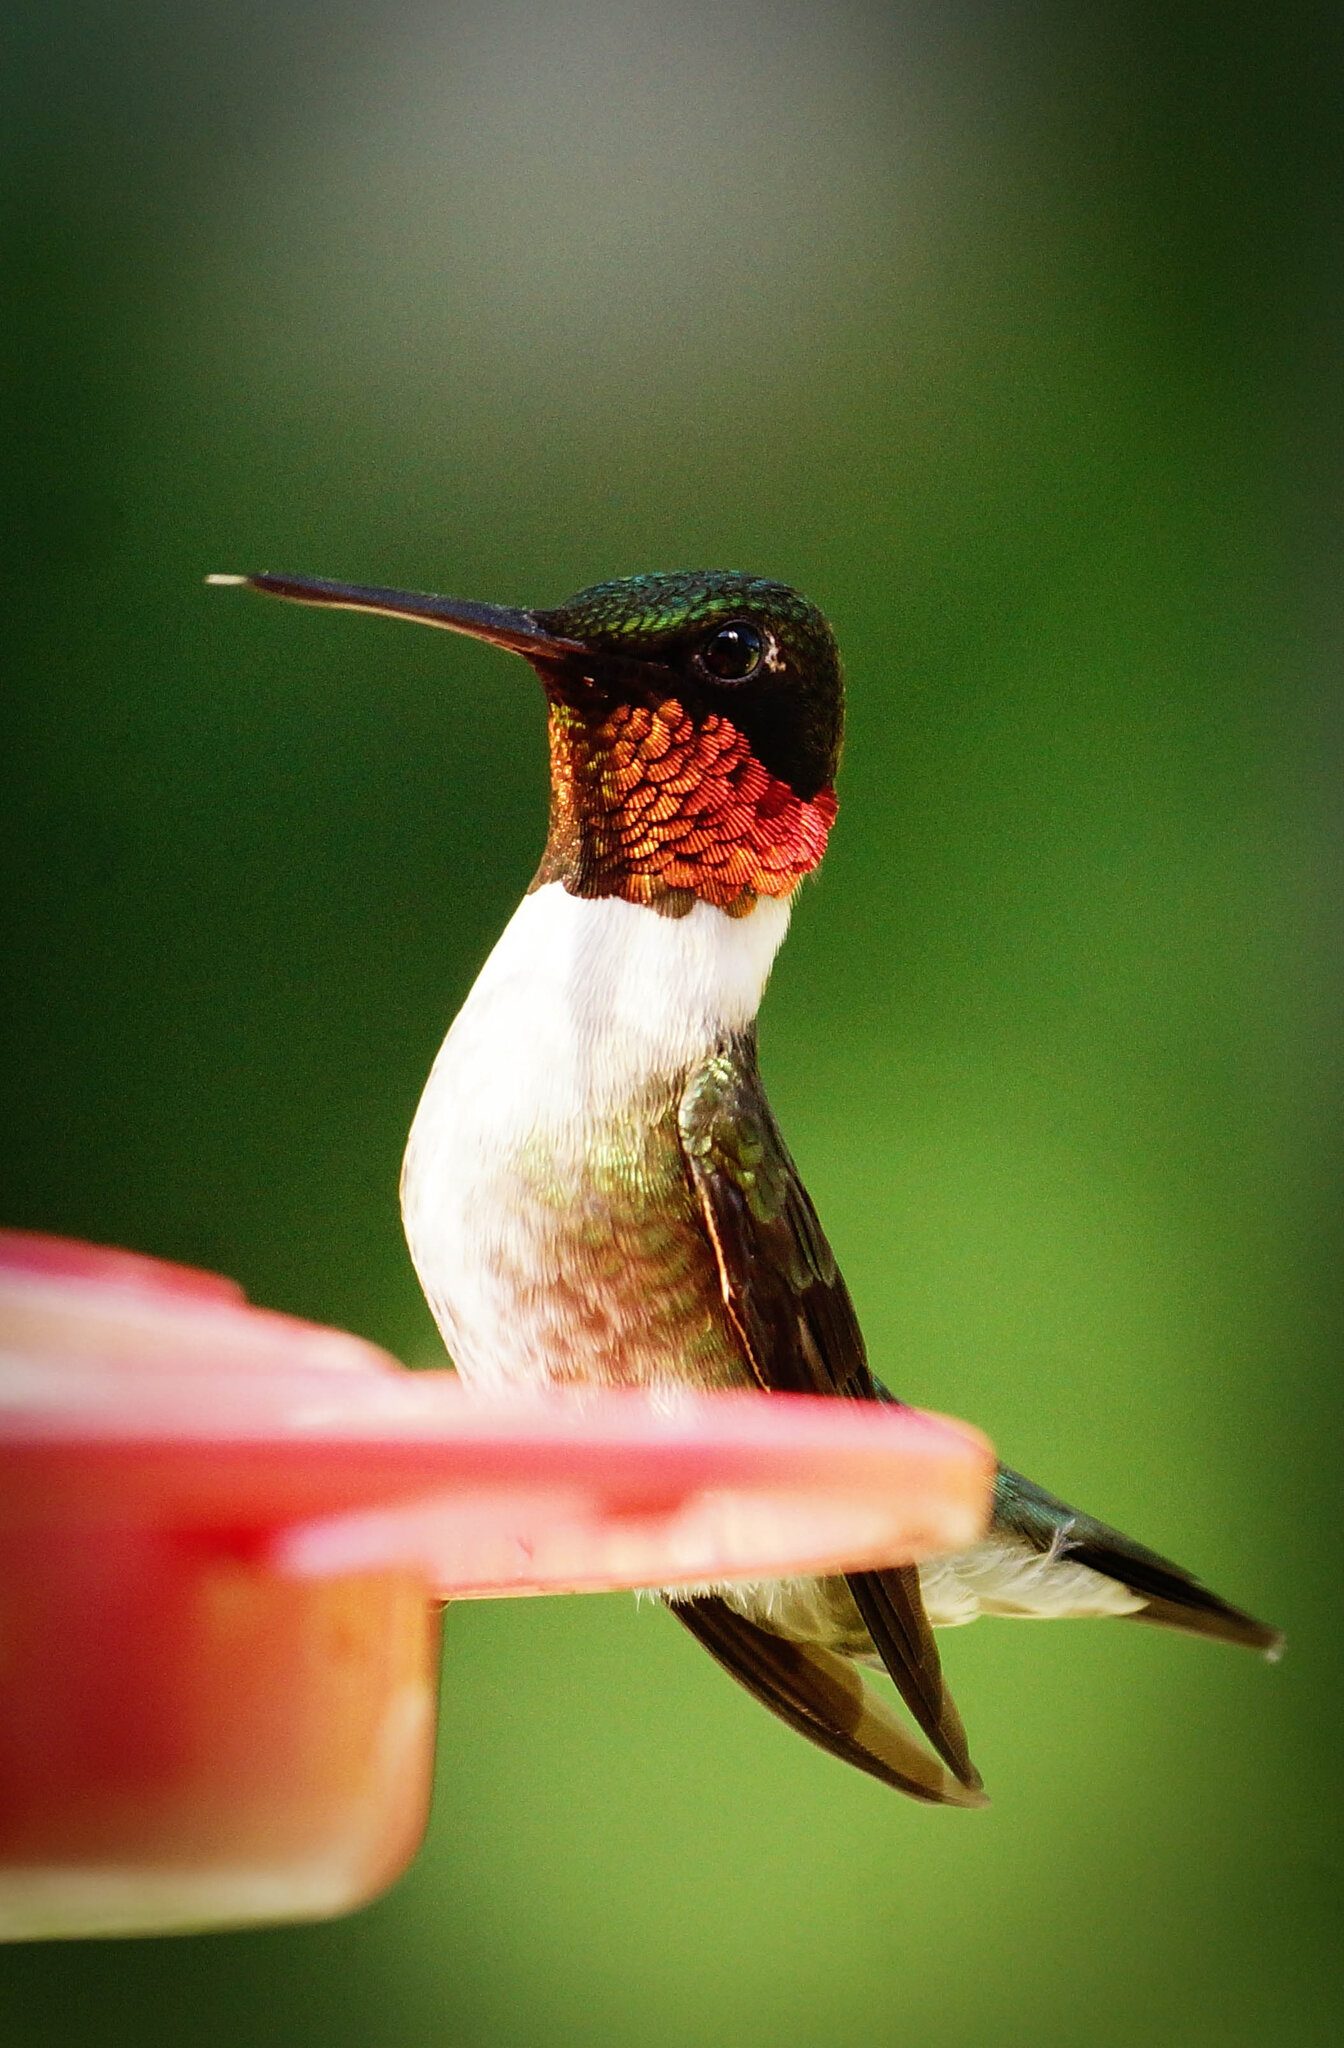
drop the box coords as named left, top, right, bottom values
left=215, top=569, right=844, bottom=915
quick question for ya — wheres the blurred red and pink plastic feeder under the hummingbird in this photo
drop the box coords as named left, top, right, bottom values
left=0, top=1233, right=994, bottom=1939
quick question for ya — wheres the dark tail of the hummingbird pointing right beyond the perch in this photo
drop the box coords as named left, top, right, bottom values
left=994, top=1464, right=1283, bottom=1657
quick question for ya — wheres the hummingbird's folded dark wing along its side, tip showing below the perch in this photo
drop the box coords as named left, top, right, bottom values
left=680, top=1032, right=981, bottom=1796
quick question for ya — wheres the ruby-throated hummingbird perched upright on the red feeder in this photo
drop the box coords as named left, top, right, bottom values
left=213, top=569, right=1280, bottom=1806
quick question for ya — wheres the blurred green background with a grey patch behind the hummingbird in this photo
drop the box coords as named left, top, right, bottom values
left=0, top=0, right=1342, bottom=2048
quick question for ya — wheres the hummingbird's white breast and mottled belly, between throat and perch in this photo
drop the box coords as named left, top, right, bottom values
left=402, top=883, right=789, bottom=1386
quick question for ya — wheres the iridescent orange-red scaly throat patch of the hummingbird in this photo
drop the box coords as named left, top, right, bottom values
left=535, top=698, right=836, bottom=915
